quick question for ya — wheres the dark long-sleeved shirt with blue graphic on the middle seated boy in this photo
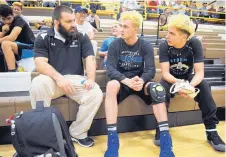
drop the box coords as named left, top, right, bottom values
left=107, top=38, right=155, bottom=82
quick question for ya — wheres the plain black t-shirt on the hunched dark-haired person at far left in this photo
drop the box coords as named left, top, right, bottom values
left=0, top=16, right=35, bottom=44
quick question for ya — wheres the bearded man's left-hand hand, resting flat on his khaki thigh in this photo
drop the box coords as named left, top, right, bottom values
left=56, top=77, right=75, bottom=95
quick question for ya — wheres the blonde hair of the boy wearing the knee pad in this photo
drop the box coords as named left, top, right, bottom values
left=120, top=11, right=143, bottom=28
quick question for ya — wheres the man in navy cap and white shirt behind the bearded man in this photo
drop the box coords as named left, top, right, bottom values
left=75, top=6, right=97, bottom=55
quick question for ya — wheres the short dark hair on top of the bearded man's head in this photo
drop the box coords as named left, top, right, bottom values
left=52, top=5, right=73, bottom=21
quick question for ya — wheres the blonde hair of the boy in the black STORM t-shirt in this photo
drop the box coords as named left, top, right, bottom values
left=168, top=14, right=195, bottom=38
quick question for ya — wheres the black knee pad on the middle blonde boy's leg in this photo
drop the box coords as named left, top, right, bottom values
left=147, top=82, right=166, bottom=104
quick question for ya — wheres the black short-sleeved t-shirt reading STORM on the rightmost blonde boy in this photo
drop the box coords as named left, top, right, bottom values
left=159, top=37, right=204, bottom=79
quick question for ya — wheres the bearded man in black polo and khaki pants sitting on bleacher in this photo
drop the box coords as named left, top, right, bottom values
left=30, top=6, right=103, bottom=147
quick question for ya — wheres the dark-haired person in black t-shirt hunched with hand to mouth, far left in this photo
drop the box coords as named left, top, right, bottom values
left=0, top=4, right=35, bottom=71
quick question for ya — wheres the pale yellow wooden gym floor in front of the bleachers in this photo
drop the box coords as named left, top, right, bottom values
left=0, top=121, right=226, bottom=157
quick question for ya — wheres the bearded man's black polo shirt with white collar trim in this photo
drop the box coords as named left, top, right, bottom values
left=34, top=28, right=94, bottom=75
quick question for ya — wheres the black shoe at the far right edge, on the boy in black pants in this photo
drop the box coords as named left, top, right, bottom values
left=206, top=131, right=225, bottom=152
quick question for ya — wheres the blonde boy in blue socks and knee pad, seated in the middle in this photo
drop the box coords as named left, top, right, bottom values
left=105, top=11, right=174, bottom=157
